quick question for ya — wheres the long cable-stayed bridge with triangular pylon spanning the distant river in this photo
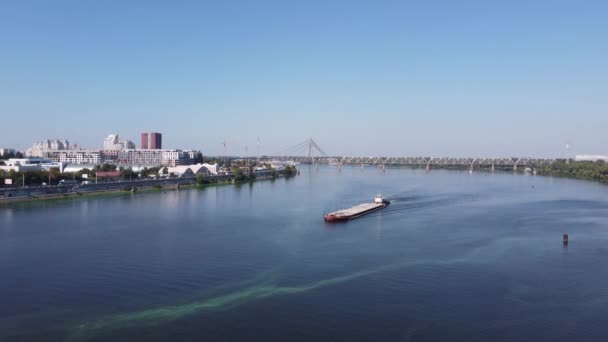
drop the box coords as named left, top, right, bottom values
left=266, top=138, right=557, bottom=170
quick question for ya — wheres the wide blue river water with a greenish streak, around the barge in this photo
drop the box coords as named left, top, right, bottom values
left=0, top=166, right=608, bottom=342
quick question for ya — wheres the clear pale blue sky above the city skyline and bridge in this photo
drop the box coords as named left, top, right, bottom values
left=0, top=0, right=608, bottom=157
